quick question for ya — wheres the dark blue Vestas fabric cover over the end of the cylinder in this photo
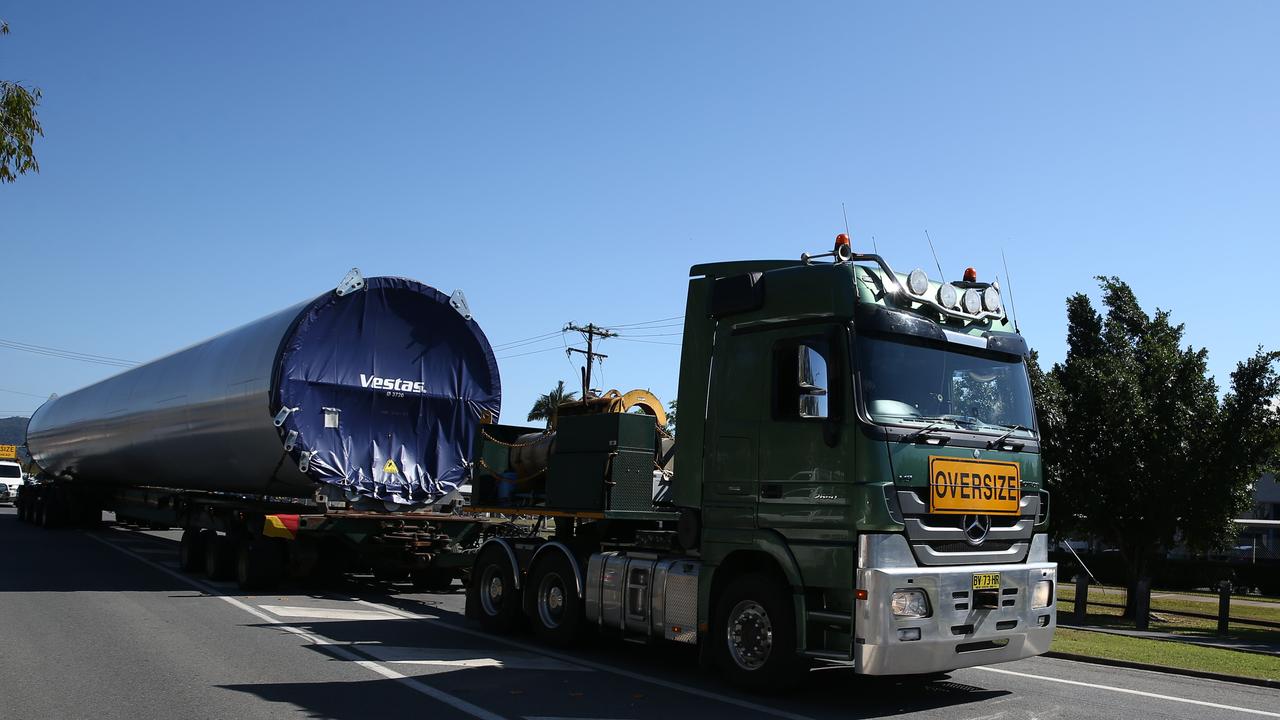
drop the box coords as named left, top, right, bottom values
left=274, top=278, right=502, bottom=503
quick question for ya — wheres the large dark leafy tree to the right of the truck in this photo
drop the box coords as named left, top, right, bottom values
left=1032, top=277, right=1280, bottom=614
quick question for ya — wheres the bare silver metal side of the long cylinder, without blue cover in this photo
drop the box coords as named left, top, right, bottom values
left=27, top=295, right=314, bottom=497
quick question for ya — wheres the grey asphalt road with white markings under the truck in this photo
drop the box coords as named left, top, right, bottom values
left=0, top=507, right=1280, bottom=720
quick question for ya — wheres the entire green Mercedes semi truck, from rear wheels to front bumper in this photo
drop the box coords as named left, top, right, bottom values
left=467, top=236, right=1056, bottom=689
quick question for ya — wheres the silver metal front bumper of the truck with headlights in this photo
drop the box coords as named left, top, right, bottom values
left=854, top=534, right=1057, bottom=675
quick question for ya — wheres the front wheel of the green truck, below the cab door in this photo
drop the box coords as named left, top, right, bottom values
left=708, top=573, right=806, bottom=692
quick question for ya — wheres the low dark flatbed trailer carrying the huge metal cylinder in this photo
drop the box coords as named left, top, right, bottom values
left=18, top=483, right=493, bottom=591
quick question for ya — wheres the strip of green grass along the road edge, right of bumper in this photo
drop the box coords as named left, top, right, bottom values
left=1051, top=628, right=1280, bottom=680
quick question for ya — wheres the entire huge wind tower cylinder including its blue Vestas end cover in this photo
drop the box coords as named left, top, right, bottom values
left=27, top=278, right=500, bottom=503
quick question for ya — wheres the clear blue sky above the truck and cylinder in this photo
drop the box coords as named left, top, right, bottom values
left=0, top=1, right=1280, bottom=420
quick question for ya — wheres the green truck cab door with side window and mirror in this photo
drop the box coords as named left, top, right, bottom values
left=758, top=327, right=854, bottom=543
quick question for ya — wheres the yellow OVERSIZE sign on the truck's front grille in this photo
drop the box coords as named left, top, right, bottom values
left=929, top=455, right=1023, bottom=515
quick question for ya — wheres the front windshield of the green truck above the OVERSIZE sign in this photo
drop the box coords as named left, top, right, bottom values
left=856, top=334, right=1036, bottom=437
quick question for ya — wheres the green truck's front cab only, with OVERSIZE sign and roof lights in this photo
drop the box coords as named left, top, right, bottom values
left=672, top=242, right=1056, bottom=676
